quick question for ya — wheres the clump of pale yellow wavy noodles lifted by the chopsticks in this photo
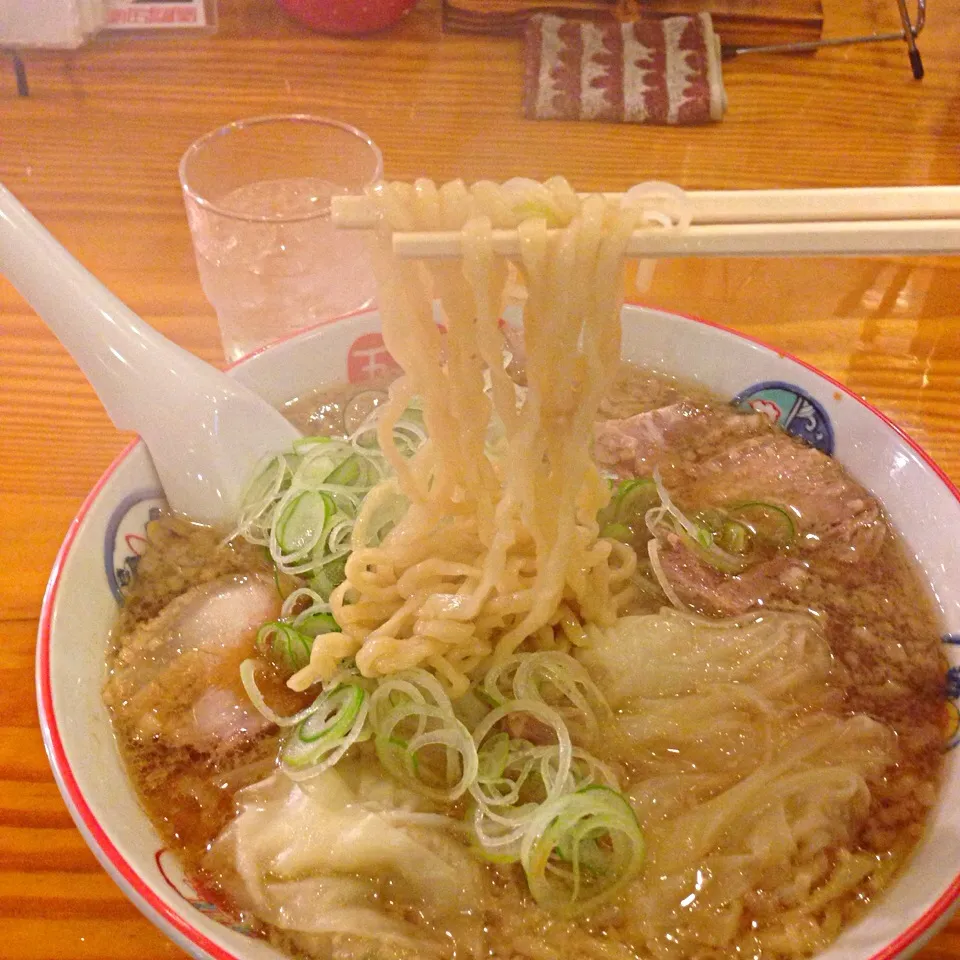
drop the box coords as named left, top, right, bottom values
left=292, top=178, right=683, bottom=696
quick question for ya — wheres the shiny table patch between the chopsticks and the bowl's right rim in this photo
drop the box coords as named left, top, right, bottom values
left=627, top=258, right=960, bottom=480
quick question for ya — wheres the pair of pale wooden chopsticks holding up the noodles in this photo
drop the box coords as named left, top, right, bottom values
left=332, top=186, right=960, bottom=258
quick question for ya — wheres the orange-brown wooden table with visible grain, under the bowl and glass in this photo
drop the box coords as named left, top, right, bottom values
left=0, top=0, right=960, bottom=960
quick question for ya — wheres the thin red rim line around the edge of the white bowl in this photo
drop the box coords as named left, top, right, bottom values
left=37, top=308, right=960, bottom=960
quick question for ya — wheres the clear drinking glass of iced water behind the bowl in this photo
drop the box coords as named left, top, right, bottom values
left=180, top=114, right=383, bottom=361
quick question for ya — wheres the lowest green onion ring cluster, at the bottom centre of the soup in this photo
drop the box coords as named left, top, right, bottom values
left=520, top=786, right=646, bottom=916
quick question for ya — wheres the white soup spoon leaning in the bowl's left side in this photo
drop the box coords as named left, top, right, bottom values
left=0, top=184, right=300, bottom=524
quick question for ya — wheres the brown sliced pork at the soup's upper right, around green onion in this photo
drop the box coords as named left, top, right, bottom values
left=595, top=402, right=887, bottom=615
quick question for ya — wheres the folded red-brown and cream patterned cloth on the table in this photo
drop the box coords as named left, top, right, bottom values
left=524, top=13, right=727, bottom=124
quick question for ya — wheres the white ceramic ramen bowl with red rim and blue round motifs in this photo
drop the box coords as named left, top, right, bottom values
left=37, top=307, right=960, bottom=960
